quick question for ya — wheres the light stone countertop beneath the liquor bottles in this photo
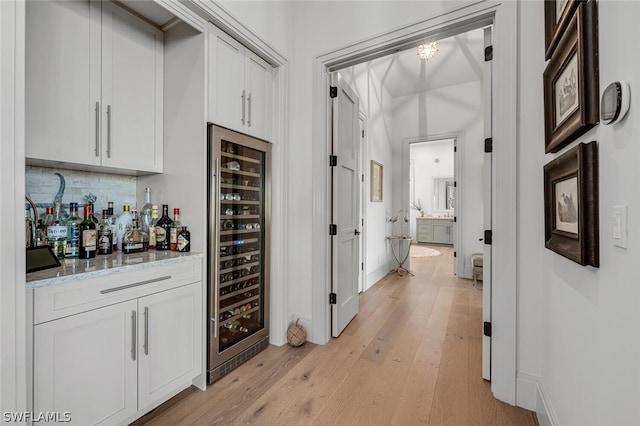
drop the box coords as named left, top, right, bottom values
left=26, top=250, right=203, bottom=290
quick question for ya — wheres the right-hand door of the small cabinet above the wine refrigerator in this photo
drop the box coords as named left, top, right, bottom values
left=245, top=52, right=273, bottom=140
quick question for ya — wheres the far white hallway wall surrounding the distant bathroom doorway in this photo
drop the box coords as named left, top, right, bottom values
left=393, top=81, right=484, bottom=278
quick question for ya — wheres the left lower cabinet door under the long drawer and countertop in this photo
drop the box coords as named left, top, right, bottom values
left=33, top=300, right=138, bottom=426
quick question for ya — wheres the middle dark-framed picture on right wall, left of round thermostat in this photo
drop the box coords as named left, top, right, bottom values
left=543, top=0, right=599, bottom=153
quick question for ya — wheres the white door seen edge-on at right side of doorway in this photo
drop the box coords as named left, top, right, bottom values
left=479, top=27, right=493, bottom=380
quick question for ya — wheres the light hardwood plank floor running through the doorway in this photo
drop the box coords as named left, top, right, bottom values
left=135, top=247, right=537, bottom=426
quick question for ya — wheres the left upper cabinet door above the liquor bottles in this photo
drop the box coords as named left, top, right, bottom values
left=25, top=1, right=100, bottom=165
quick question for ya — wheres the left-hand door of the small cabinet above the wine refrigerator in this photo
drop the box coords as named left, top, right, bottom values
left=209, top=25, right=247, bottom=132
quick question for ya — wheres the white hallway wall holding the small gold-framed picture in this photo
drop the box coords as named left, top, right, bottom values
left=340, top=64, right=398, bottom=290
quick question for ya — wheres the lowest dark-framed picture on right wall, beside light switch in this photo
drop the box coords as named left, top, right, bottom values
left=544, top=142, right=600, bottom=267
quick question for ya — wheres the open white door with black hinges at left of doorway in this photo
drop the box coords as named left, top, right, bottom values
left=329, top=73, right=360, bottom=337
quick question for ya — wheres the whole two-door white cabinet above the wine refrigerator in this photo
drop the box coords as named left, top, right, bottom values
left=209, top=24, right=272, bottom=140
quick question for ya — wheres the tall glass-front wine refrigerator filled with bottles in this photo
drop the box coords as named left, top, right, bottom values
left=207, top=124, right=271, bottom=383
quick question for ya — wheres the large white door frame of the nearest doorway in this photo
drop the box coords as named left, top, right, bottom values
left=311, top=1, right=518, bottom=405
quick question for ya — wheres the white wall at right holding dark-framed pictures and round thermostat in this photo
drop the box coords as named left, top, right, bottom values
left=517, top=1, right=640, bottom=425
